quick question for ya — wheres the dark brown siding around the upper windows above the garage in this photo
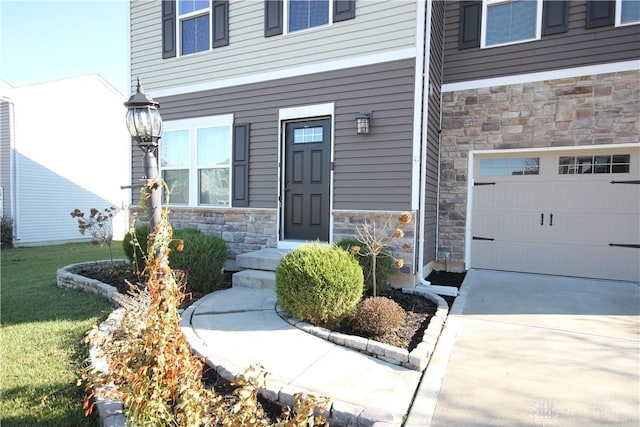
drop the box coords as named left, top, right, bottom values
left=444, top=1, right=640, bottom=83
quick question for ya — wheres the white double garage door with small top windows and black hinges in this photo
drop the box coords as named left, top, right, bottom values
left=470, top=148, right=640, bottom=281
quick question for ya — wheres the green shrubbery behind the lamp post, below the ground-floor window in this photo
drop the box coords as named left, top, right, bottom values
left=122, top=224, right=229, bottom=293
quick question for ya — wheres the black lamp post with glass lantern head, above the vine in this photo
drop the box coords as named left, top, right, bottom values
left=124, top=77, right=162, bottom=233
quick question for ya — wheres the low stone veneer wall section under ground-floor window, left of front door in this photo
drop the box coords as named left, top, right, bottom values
left=164, top=207, right=277, bottom=259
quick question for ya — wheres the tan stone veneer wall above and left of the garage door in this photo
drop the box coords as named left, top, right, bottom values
left=438, top=71, right=640, bottom=262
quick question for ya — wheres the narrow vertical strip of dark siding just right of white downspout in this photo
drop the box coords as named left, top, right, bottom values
left=423, top=1, right=445, bottom=262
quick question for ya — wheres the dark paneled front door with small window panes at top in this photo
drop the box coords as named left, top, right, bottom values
left=283, top=119, right=331, bottom=242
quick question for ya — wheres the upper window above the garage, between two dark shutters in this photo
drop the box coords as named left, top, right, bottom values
left=482, top=0, right=542, bottom=47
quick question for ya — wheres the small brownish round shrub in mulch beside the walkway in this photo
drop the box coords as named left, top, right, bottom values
left=352, top=297, right=405, bottom=336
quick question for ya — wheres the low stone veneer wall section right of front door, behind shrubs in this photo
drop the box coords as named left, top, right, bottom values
left=333, top=211, right=417, bottom=274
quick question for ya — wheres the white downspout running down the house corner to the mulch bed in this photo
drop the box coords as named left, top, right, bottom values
left=417, top=1, right=458, bottom=296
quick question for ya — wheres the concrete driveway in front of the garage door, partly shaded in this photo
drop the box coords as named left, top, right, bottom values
left=405, top=270, right=640, bottom=427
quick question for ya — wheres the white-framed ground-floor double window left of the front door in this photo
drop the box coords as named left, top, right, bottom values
left=160, top=115, right=233, bottom=207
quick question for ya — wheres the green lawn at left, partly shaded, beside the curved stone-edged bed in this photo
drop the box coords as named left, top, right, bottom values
left=0, top=242, right=125, bottom=427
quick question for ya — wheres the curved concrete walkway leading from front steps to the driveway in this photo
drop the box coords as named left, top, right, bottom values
left=181, top=288, right=422, bottom=427
